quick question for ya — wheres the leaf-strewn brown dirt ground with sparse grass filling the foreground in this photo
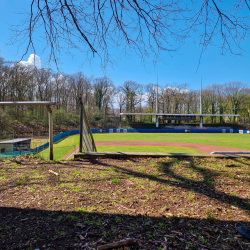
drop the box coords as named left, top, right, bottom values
left=0, top=157, right=250, bottom=250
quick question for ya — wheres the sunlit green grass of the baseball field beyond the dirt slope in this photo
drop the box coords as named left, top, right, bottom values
left=37, top=133, right=250, bottom=160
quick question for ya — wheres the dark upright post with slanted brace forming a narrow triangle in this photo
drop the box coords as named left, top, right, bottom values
left=79, top=97, right=97, bottom=153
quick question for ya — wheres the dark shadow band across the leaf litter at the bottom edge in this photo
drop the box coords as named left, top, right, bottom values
left=0, top=207, right=250, bottom=250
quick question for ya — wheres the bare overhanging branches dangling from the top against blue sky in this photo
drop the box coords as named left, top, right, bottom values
left=14, top=0, right=250, bottom=66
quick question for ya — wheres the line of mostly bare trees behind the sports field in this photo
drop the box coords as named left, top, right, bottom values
left=0, top=55, right=250, bottom=139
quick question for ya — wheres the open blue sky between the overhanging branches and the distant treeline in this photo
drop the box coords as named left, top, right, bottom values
left=0, top=0, right=250, bottom=89
